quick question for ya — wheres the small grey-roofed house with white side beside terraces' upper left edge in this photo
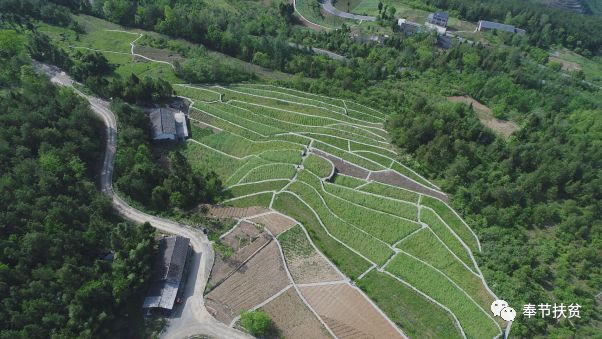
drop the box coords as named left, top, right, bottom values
left=150, top=107, right=188, bottom=140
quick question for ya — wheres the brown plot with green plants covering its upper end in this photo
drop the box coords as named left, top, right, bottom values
left=278, top=226, right=344, bottom=284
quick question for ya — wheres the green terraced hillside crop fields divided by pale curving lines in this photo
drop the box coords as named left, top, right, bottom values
left=180, top=84, right=504, bottom=338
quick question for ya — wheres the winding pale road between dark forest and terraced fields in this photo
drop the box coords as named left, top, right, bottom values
left=36, top=64, right=249, bottom=339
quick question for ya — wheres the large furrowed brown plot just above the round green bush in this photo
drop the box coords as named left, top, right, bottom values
left=205, top=241, right=290, bottom=324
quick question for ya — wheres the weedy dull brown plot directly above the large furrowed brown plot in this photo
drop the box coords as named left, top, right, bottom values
left=208, top=222, right=271, bottom=286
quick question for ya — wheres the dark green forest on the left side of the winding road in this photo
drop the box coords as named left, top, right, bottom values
left=0, top=30, right=153, bottom=338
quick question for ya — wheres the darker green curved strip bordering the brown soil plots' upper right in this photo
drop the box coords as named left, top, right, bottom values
left=272, top=193, right=370, bottom=279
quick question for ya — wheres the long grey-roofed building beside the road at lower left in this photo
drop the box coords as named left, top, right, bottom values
left=143, top=236, right=190, bottom=314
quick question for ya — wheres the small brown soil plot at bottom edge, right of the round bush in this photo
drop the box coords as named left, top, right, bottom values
left=262, top=288, right=332, bottom=339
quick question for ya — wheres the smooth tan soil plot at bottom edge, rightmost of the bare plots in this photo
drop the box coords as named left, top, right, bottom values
left=300, top=284, right=404, bottom=338
